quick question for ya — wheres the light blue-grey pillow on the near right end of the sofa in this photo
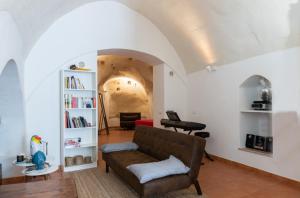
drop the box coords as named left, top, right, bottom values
left=127, top=155, right=190, bottom=184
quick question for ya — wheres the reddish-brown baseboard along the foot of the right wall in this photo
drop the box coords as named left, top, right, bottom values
left=210, top=154, right=300, bottom=188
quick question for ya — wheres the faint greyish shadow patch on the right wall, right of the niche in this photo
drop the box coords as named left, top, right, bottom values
left=273, top=111, right=300, bottom=178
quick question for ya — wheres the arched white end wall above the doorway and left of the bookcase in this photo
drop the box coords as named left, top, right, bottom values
left=25, top=1, right=186, bottom=166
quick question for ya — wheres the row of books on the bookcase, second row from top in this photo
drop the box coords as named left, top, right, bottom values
left=64, top=94, right=96, bottom=109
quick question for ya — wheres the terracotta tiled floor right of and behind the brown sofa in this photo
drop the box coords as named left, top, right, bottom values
left=99, top=131, right=300, bottom=198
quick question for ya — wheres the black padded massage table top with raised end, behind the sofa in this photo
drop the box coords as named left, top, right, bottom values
left=160, top=111, right=206, bottom=135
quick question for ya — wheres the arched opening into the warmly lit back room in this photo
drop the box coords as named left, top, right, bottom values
left=98, top=49, right=164, bottom=130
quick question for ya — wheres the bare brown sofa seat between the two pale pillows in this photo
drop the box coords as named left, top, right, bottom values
left=109, top=151, right=158, bottom=169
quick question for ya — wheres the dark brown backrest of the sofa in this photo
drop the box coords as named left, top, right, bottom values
left=133, top=126, right=205, bottom=179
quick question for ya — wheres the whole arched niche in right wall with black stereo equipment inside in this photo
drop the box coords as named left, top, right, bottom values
left=239, top=75, right=273, bottom=157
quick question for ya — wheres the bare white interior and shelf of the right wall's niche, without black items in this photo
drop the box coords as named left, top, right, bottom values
left=238, top=75, right=273, bottom=157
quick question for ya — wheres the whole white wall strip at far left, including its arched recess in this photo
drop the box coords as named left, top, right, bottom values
left=0, top=11, right=25, bottom=178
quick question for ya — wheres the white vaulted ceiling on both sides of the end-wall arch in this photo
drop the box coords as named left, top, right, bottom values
left=0, top=0, right=300, bottom=72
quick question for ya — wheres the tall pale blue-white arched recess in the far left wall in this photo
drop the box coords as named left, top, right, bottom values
left=0, top=60, right=26, bottom=178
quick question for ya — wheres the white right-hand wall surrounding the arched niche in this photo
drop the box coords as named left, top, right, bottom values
left=188, top=48, right=300, bottom=180
